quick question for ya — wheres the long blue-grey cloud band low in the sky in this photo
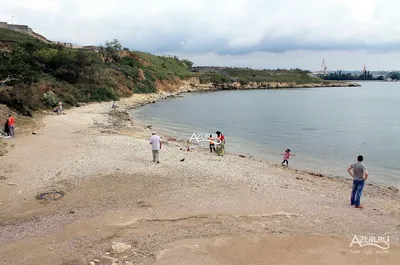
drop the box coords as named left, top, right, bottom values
left=124, top=32, right=400, bottom=55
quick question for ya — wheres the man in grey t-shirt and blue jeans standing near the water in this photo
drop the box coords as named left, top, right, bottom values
left=347, top=155, right=368, bottom=208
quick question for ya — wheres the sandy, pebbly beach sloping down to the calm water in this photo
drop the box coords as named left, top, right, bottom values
left=0, top=89, right=400, bottom=265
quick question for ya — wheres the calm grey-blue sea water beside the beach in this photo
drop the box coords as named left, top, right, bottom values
left=132, top=82, right=400, bottom=187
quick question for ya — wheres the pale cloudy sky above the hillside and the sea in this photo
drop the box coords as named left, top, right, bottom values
left=0, top=0, right=400, bottom=71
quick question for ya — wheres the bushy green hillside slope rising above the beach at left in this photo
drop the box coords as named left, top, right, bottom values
left=0, top=29, right=193, bottom=115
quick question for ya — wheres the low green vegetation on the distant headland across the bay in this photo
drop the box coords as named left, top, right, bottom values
left=201, top=68, right=323, bottom=85
